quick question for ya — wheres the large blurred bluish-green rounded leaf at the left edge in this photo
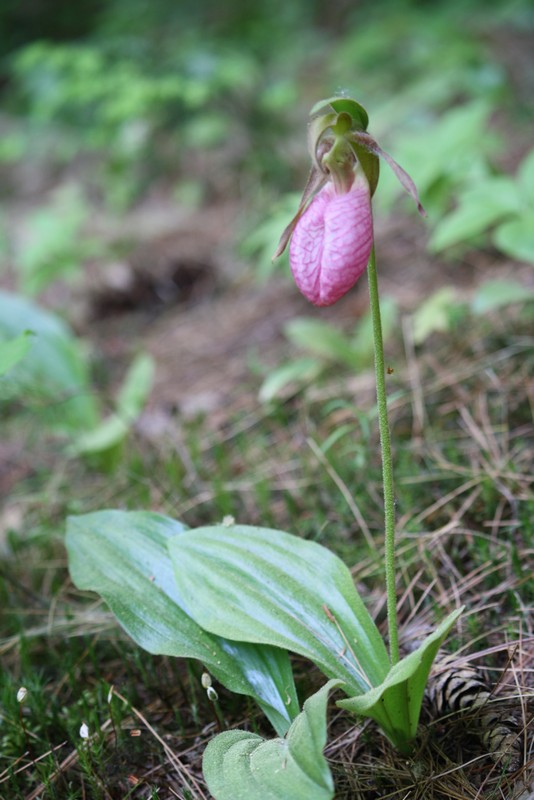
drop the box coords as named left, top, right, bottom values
left=0, top=290, right=98, bottom=432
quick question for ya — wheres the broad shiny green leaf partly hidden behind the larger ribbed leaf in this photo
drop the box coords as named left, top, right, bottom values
left=66, top=510, right=299, bottom=733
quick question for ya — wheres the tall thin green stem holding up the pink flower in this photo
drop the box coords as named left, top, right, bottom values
left=367, top=245, right=399, bottom=664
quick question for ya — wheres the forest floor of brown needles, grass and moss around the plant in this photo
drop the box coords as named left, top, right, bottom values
left=0, top=122, right=534, bottom=800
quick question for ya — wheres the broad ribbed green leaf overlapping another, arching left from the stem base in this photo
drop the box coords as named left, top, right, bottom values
left=169, top=525, right=389, bottom=694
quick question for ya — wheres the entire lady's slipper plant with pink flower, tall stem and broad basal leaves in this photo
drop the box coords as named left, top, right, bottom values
left=67, top=97, right=461, bottom=800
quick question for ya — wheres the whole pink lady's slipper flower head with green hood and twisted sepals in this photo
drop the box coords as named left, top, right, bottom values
left=275, top=97, right=425, bottom=306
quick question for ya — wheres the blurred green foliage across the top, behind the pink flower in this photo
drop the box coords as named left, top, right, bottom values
left=0, top=0, right=534, bottom=438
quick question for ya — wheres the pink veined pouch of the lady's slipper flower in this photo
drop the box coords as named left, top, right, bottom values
left=289, top=175, right=373, bottom=306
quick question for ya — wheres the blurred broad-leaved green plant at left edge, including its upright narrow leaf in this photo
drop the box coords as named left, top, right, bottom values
left=0, top=291, right=154, bottom=465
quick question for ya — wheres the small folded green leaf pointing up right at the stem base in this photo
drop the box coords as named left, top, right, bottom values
left=337, top=609, right=463, bottom=752
